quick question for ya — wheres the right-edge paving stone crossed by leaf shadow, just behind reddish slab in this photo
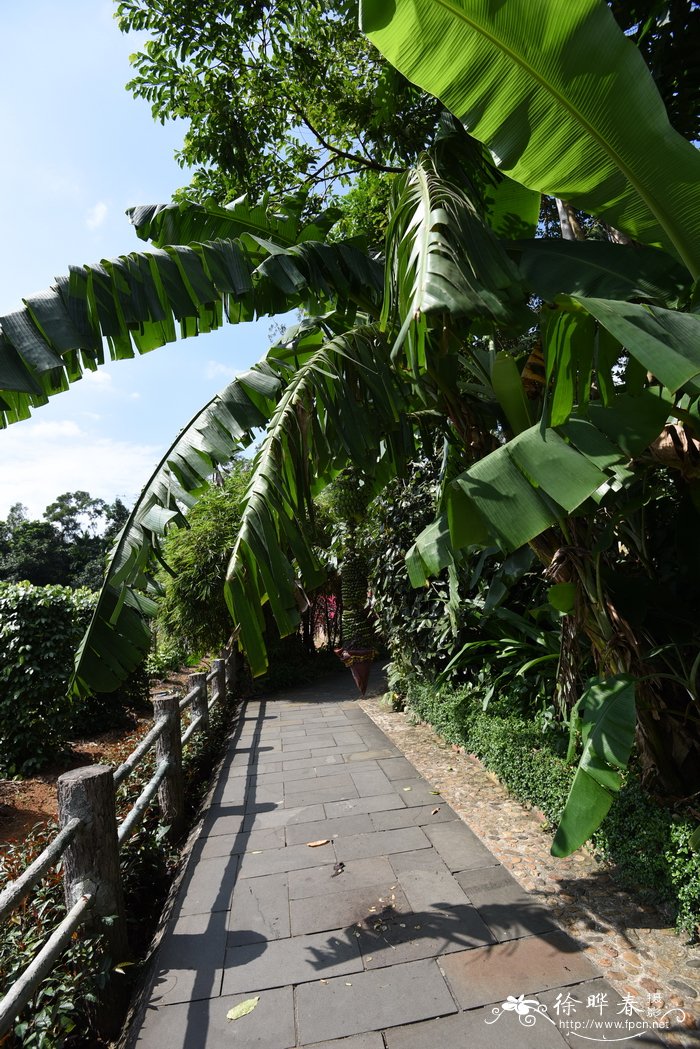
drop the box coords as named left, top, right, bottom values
left=454, top=865, right=558, bottom=940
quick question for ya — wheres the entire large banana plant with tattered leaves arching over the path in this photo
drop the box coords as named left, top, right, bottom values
left=0, top=0, right=700, bottom=850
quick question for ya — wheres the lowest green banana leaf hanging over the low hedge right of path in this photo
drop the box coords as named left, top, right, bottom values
left=552, top=675, right=636, bottom=856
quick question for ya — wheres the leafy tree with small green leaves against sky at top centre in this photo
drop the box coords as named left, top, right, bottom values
left=118, top=0, right=439, bottom=202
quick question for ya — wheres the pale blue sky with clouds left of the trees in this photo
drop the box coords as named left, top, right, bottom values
left=0, top=0, right=279, bottom=518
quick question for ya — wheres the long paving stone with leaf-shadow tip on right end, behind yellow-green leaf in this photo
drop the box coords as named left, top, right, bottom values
left=222, top=932, right=362, bottom=994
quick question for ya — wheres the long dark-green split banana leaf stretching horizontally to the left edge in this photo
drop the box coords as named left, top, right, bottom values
left=0, top=197, right=382, bottom=426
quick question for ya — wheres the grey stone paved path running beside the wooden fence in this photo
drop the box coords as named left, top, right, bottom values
left=126, top=675, right=661, bottom=1049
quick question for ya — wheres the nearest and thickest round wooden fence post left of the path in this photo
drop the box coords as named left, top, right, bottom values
left=58, top=765, right=129, bottom=1037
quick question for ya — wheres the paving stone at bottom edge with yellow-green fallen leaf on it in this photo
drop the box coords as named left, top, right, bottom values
left=135, top=987, right=296, bottom=1049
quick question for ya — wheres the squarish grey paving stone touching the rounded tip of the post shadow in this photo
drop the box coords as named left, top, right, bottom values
left=227, top=874, right=290, bottom=947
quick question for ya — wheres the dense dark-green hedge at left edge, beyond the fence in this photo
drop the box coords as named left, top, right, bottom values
left=0, top=583, right=94, bottom=776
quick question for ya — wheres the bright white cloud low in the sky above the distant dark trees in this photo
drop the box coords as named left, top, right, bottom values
left=0, top=420, right=160, bottom=518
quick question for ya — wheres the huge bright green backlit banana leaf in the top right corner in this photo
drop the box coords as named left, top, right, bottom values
left=360, top=0, right=700, bottom=277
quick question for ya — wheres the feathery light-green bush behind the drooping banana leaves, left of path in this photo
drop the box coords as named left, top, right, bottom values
left=160, top=461, right=251, bottom=654
